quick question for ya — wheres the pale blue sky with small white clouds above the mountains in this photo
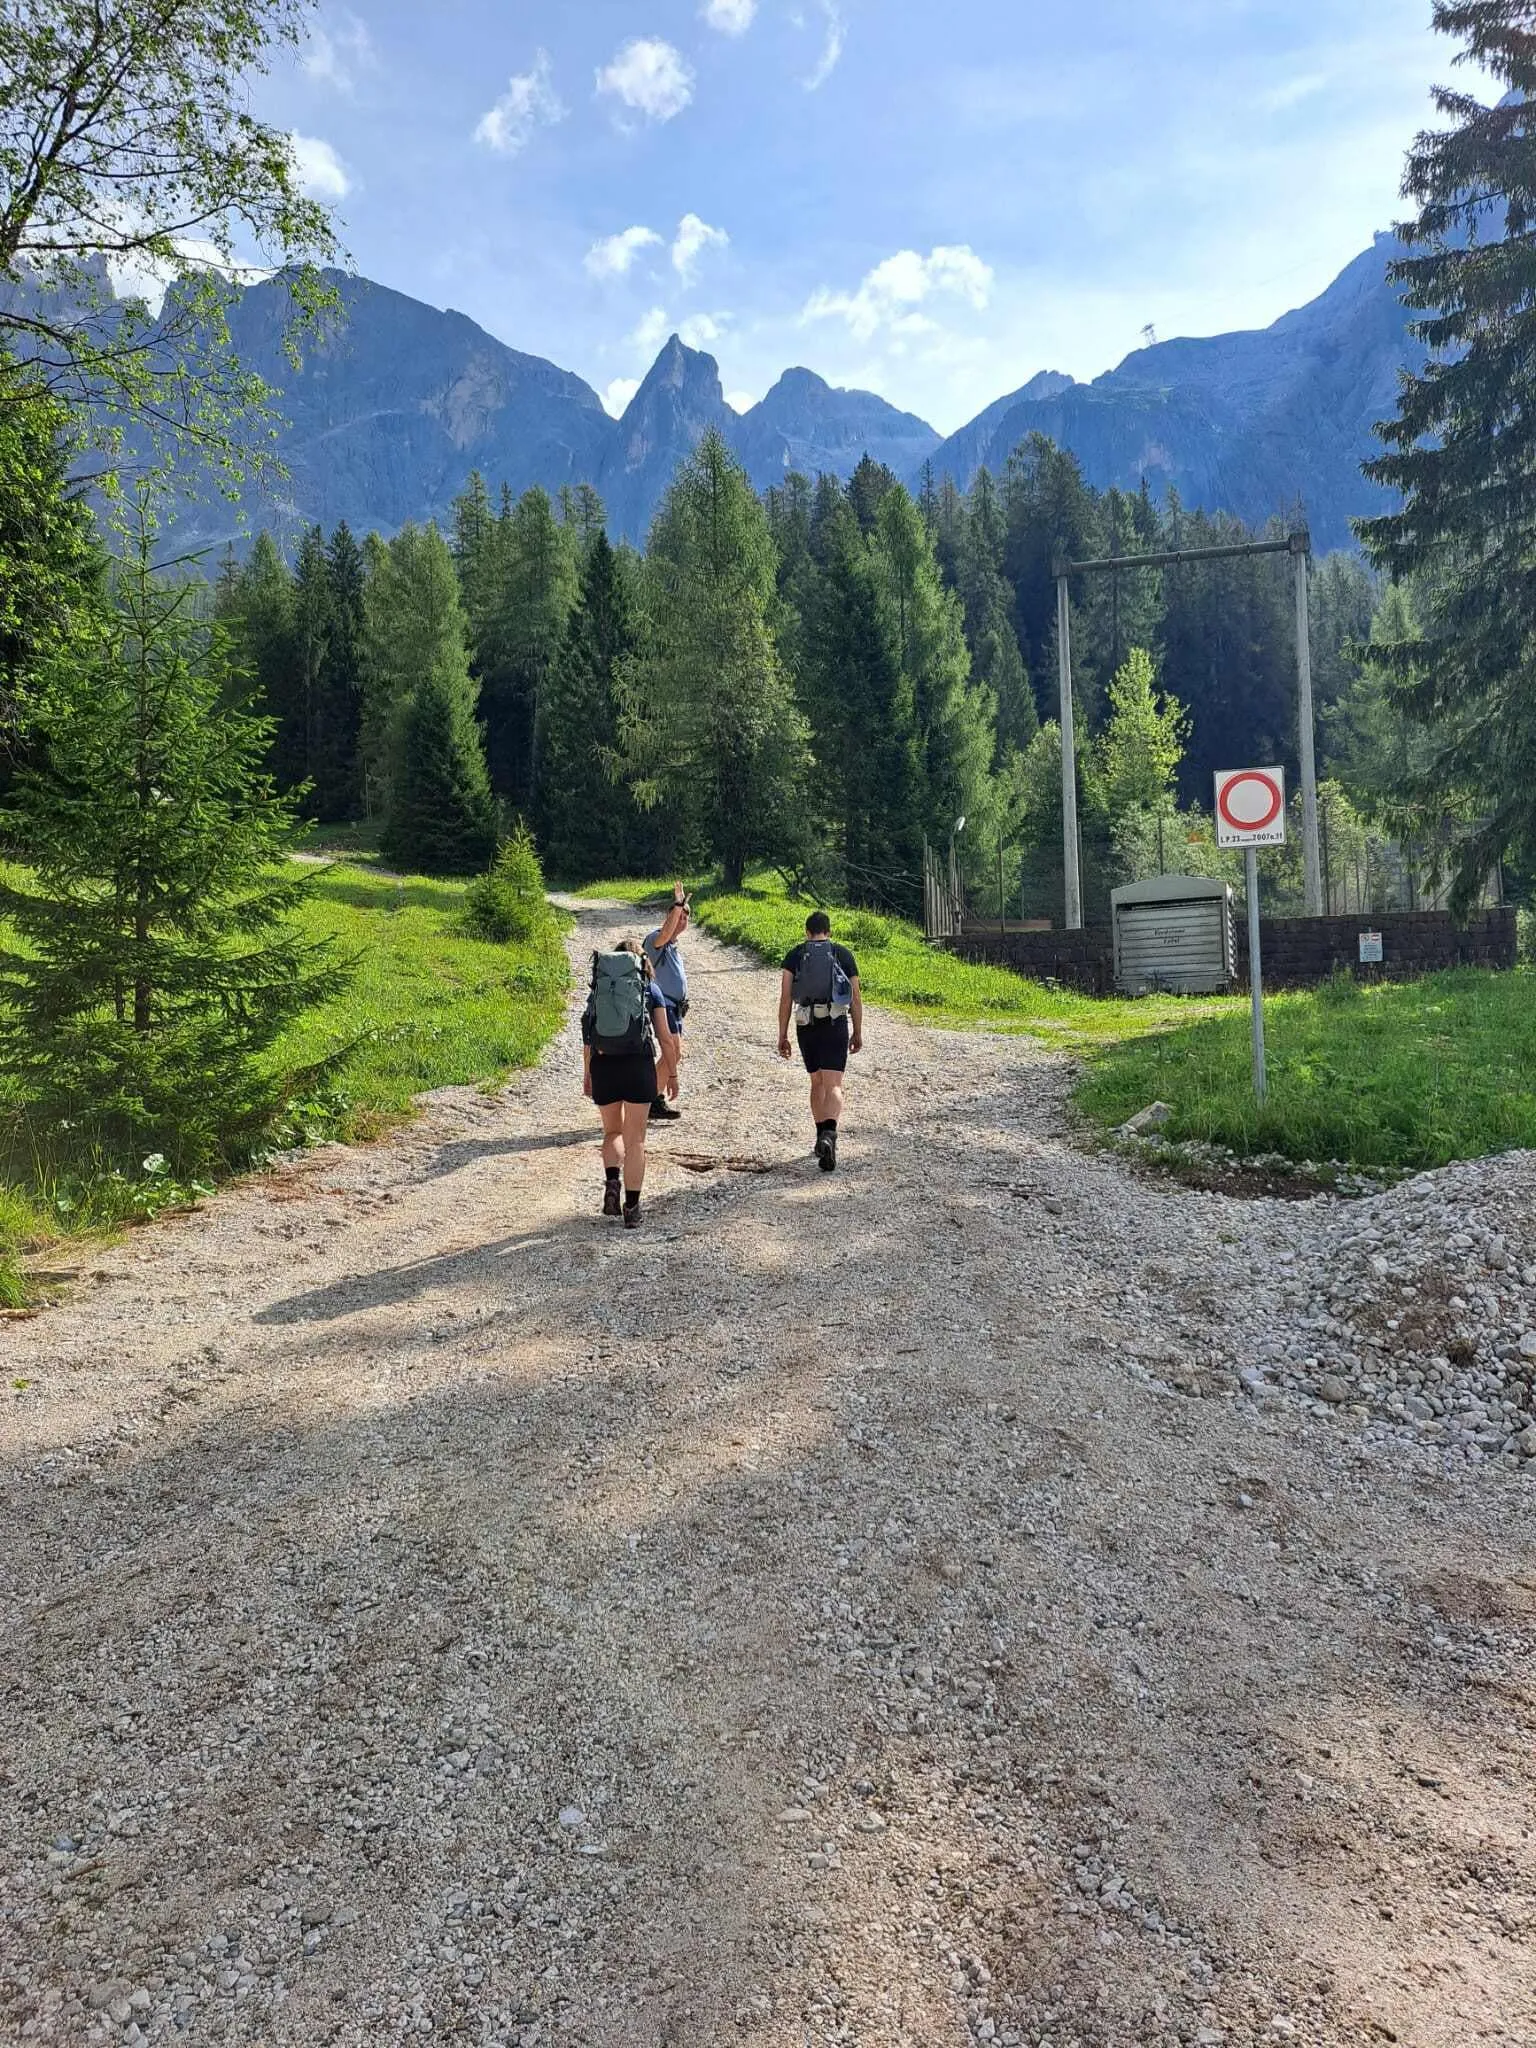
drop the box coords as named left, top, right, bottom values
left=260, top=0, right=1454, bottom=432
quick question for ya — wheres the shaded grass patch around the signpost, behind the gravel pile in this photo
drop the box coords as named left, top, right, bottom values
left=1077, top=969, right=1536, bottom=1171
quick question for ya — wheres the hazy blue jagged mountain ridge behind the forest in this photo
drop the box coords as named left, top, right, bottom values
left=41, top=236, right=1421, bottom=547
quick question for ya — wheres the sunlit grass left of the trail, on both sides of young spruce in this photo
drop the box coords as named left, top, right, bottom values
left=0, top=864, right=569, bottom=1307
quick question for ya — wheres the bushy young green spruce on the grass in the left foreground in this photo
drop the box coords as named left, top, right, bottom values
left=0, top=514, right=344, bottom=1171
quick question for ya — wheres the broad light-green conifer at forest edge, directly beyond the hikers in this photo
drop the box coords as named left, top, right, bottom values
left=621, top=430, right=807, bottom=887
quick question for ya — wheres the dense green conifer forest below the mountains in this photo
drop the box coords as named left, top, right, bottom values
left=213, top=436, right=1405, bottom=918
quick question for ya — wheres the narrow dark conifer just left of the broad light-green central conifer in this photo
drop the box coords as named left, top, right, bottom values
left=539, top=530, right=639, bottom=881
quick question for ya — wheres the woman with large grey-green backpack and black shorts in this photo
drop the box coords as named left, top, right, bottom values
left=582, top=938, right=678, bottom=1231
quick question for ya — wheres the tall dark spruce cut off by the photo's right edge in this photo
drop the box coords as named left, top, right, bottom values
left=1358, top=0, right=1536, bottom=907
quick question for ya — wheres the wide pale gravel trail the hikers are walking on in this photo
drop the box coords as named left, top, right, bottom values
left=0, top=907, right=1536, bottom=2048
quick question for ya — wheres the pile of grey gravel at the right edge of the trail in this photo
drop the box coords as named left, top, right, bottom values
left=1237, top=1153, right=1536, bottom=1477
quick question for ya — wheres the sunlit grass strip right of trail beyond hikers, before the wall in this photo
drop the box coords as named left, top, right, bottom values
left=582, top=877, right=1231, bottom=1049
